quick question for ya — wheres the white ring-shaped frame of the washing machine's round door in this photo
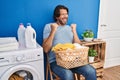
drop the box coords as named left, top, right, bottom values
left=1, top=65, right=43, bottom=80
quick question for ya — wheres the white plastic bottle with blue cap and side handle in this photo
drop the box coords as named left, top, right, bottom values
left=25, top=23, right=37, bottom=48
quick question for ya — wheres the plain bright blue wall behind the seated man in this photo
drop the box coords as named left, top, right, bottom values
left=0, top=0, right=100, bottom=45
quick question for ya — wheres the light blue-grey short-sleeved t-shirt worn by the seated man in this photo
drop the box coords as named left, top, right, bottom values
left=43, top=23, right=73, bottom=63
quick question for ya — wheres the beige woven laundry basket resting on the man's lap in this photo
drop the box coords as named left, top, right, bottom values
left=55, top=47, right=89, bottom=69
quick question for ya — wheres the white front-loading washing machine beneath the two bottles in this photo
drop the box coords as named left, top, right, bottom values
left=0, top=46, right=44, bottom=80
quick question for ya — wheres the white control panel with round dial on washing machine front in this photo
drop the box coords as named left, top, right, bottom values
left=0, top=47, right=43, bottom=66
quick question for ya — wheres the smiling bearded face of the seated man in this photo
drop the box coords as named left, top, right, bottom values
left=56, top=9, right=68, bottom=25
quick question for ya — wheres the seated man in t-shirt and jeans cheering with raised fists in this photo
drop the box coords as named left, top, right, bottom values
left=43, top=5, right=96, bottom=80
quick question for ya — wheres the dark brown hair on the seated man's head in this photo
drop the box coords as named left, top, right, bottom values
left=53, top=5, right=69, bottom=21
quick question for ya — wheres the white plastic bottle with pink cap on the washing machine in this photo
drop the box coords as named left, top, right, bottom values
left=17, top=23, right=25, bottom=48
